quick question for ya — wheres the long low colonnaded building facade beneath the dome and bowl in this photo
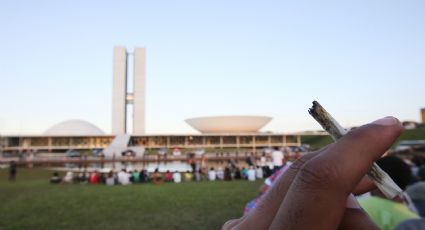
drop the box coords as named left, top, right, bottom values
left=0, top=133, right=301, bottom=152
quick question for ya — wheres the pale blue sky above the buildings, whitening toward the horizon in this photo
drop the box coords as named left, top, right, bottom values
left=0, top=0, right=425, bottom=135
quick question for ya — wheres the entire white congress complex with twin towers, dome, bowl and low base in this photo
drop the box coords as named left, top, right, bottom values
left=0, top=47, right=301, bottom=153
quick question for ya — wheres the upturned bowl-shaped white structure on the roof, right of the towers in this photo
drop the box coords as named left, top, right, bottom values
left=185, top=116, right=272, bottom=133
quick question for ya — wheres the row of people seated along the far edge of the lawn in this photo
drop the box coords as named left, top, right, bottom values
left=50, top=148, right=285, bottom=185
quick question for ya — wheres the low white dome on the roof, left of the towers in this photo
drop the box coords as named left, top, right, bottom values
left=44, top=120, right=105, bottom=136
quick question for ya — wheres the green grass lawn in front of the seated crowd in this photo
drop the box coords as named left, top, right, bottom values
left=0, top=169, right=262, bottom=229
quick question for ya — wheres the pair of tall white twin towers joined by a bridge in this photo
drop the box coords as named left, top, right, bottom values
left=112, top=46, right=146, bottom=135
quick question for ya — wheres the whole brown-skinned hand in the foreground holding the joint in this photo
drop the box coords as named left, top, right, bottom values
left=223, top=118, right=403, bottom=230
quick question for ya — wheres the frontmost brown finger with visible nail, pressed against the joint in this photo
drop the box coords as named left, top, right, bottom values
left=271, top=118, right=402, bottom=229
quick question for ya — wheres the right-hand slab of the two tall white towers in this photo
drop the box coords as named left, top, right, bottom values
left=133, top=48, right=146, bottom=135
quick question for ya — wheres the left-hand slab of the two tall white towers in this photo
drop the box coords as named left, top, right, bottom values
left=112, top=46, right=127, bottom=135
